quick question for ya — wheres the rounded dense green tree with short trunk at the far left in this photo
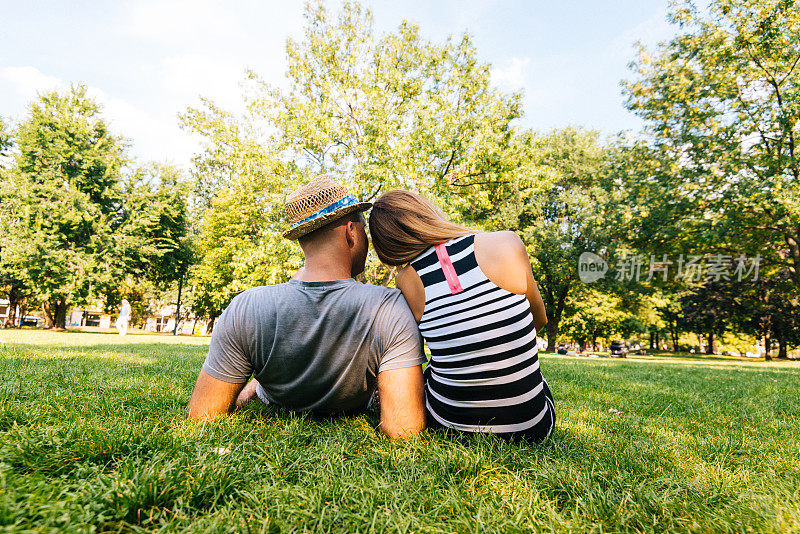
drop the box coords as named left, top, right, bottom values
left=0, top=86, right=123, bottom=328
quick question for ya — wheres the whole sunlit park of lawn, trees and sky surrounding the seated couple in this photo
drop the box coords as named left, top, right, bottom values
left=0, top=0, right=800, bottom=532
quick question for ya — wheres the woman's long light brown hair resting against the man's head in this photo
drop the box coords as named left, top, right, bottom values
left=369, top=193, right=473, bottom=266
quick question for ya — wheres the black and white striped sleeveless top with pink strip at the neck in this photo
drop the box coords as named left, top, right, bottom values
left=411, top=235, right=555, bottom=438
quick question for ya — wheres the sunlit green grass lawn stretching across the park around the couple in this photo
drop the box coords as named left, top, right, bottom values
left=0, top=331, right=800, bottom=532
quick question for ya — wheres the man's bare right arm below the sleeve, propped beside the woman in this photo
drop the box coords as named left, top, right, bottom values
left=378, top=365, right=425, bottom=439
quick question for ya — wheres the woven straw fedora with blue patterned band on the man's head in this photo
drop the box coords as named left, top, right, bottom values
left=283, top=174, right=372, bottom=239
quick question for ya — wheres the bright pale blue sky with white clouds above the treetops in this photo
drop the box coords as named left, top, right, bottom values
left=0, top=0, right=675, bottom=165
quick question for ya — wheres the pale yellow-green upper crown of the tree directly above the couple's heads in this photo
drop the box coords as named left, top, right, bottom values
left=258, top=2, right=532, bottom=207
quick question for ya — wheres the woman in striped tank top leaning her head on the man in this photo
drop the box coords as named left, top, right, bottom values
left=369, top=190, right=555, bottom=440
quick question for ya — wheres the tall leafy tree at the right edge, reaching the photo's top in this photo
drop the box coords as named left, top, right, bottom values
left=625, top=0, right=800, bottom=286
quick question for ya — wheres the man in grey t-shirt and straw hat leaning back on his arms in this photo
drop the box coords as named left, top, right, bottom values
left=188, top=176, right=425, bottom=438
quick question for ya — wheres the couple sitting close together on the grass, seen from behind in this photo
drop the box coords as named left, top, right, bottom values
left=189, top=176, right=555, bottom=440
